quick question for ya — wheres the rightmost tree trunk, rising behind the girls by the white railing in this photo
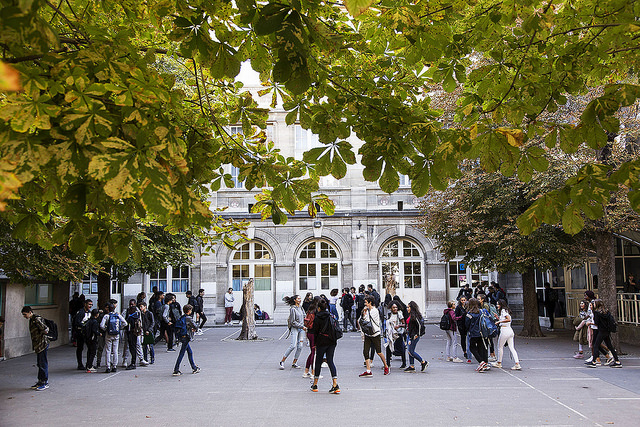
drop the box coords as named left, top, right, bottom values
left=596, top=231, right=620, bottom=350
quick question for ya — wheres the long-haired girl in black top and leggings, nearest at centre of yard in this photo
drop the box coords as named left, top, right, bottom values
left=311, top=298, right=340, bottom=394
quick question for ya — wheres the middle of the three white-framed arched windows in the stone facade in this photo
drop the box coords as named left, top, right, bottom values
left=296, top=240, right=340, bottom=291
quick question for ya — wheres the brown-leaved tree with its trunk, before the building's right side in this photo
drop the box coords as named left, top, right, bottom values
left=420, top=164, right=589, bottom=336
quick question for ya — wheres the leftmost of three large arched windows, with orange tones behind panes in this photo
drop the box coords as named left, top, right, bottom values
left=230, top=242, right=273, bottom=291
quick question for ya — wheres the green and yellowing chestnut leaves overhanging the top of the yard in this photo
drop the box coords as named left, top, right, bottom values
left=0, top=0, right=640, bottom=260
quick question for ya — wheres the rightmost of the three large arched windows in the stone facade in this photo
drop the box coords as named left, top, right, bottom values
left=380, top=239, right=422, bottom=289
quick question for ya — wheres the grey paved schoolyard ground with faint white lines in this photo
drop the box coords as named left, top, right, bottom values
left=0, top=325, right=640, bottom=426
